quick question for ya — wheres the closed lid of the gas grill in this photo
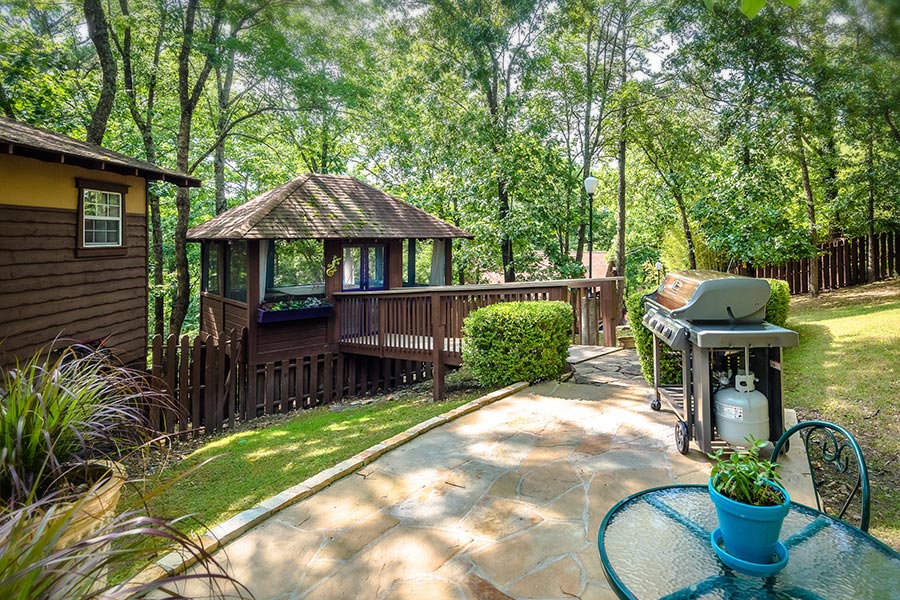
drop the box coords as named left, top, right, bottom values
left=647, top=270, right=771, bottom=323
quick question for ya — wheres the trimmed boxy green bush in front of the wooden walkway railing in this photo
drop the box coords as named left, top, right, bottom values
left=463, top=301, right=572, bottom=387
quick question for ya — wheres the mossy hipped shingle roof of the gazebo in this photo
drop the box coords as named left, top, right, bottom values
left=188, top=174, right=472, bottom=240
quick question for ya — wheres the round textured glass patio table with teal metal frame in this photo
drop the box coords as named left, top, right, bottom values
left=598, top=485, right=900, bottom=600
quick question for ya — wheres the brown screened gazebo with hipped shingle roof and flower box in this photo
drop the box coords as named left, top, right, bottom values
left=188, top=174, right=472, bottom=364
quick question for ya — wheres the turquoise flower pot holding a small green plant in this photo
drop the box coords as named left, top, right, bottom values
left=709, top=478, right=791, bottom=565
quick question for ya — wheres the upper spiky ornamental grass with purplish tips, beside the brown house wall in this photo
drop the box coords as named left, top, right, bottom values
left=0, top=347, right=156, bottom=508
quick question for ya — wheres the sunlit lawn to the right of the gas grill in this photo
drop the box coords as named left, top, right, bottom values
left=784, top=279, right=900, bottom=550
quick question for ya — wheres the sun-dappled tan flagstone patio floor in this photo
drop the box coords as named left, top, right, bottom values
left=172, top=350, right=804, bottom=600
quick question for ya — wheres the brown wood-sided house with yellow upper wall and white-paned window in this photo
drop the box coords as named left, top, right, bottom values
left=0, top=118, right=200, bottom=364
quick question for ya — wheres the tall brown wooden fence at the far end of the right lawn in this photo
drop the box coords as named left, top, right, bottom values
left=750, top=232, right=900, bottom=294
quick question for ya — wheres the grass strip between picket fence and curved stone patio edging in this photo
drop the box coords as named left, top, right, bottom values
left=132, top=387, right=485, bottom=532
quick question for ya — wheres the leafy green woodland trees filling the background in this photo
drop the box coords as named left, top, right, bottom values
left=0, top=0, right=900, bottom=332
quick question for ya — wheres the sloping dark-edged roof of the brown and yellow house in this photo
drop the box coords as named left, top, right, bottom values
left=0, top=117, right=200, bottom=187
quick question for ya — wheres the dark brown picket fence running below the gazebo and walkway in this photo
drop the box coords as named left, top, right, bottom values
left=150, top=328, right=432, bottom=437
